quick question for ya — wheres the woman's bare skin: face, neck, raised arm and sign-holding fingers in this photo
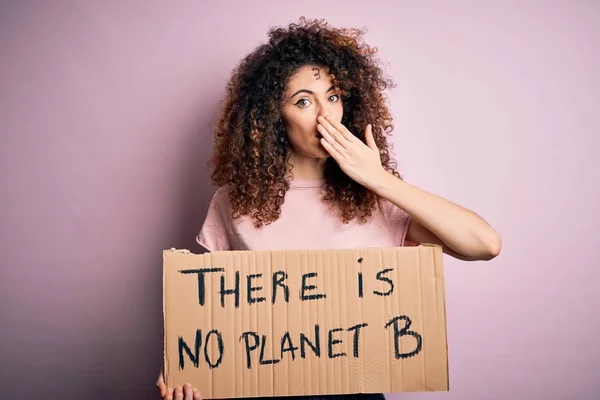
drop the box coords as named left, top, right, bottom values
left=157, top=66, right=502, bottom=400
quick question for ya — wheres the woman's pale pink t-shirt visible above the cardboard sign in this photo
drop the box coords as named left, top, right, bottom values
left=196, top=180, right=411, bottom=251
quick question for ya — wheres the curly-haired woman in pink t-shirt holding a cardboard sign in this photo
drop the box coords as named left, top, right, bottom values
left=157, top=19, right=501, bottom=399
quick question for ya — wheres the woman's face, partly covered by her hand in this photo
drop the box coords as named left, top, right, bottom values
left=281, top=66, right=343, bottom=159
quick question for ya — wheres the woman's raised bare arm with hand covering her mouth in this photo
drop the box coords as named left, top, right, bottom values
left=317, top=117, right=502, bottom=260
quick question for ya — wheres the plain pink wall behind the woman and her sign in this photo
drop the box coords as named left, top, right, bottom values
left=0, top=0, right=600, bottom=400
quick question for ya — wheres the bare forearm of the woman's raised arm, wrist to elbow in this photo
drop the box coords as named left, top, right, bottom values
left=372, top=173, right=501, bottom=259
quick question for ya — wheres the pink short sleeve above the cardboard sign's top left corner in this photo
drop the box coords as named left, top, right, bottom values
left=196, top=187, right=231, bottom=252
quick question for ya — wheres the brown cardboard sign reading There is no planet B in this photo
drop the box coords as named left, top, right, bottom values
left=163, top=245, right=448, bottom=399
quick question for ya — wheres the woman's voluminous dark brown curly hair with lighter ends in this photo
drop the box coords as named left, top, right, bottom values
left=209, top=18, right=400, bottom=227
